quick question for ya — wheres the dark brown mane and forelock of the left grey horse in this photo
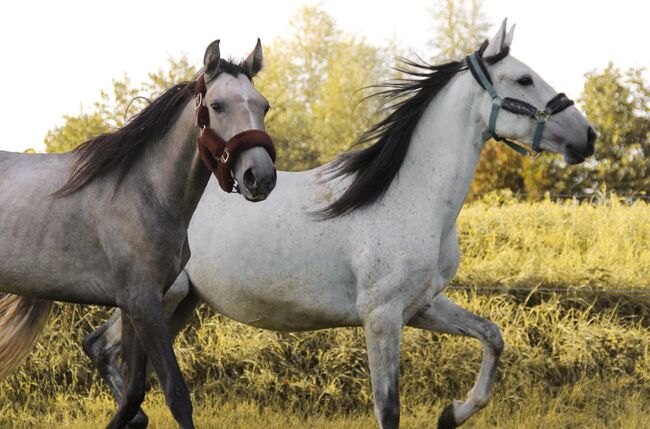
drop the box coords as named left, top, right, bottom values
left=52, top=59, right=251, bottom=198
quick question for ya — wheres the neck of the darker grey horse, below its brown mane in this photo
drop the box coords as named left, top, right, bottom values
left=136, top=100, right=210, bottom=225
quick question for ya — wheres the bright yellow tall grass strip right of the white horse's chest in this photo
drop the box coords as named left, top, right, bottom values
left=456, top=193, right=650, bottom=292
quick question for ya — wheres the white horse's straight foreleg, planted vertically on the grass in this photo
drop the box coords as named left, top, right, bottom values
left=363, top=309, right=402, bottom=429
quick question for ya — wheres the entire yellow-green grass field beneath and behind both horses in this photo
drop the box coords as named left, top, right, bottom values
left=0, top=196, right=650, bottom=429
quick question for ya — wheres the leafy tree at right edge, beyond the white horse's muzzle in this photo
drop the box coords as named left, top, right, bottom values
left=524, top=63, right=650, bottom=195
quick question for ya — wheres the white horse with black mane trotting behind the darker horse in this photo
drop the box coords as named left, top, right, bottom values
left=84, top=21, right=596, bottom=428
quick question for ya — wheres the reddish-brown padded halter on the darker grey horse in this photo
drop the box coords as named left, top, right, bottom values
left=194, top=74, right=275, bottom=192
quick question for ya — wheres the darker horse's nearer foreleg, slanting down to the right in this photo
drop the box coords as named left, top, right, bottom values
left=122, top=287, right=194, bottom=429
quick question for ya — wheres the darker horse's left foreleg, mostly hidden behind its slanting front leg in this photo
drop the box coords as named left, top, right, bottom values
left=107, top=310, right=147, bottom=429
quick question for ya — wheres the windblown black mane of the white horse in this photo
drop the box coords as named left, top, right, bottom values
left=316, top=56, right=467, bottom=219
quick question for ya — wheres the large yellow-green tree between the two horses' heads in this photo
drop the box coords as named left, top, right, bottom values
left=256, top=6, right=395, bottom=170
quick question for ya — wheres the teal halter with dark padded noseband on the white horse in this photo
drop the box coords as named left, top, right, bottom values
left=466, top=44, right=573, bottom=157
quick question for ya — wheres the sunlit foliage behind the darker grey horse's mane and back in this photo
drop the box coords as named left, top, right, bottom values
left=45, top=56, right=197, bottom=153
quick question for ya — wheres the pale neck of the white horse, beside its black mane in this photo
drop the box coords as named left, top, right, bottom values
left=387, top=73, right=484, bottom=222
